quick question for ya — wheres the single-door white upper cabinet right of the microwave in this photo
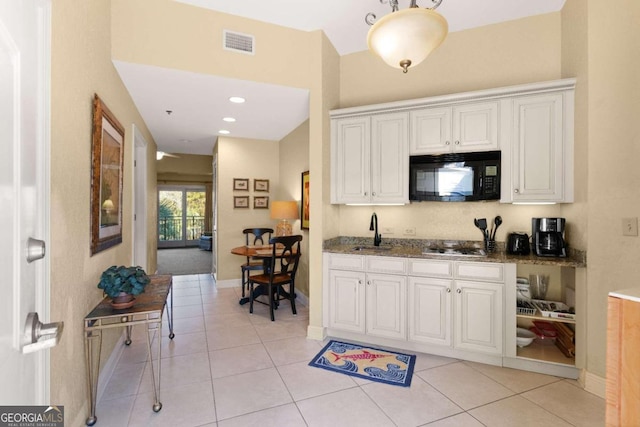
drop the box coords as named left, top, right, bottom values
left=501, top=90, right=574, bottom=203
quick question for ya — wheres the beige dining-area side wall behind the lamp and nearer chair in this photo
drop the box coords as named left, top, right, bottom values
left=280, top=120, right=311, bottom=296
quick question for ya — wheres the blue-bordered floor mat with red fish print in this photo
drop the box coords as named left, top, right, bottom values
left=309, top=340, right=416, bottom=387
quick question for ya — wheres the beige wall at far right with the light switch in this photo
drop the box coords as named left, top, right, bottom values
left=572, top=0, right=640, bottom=382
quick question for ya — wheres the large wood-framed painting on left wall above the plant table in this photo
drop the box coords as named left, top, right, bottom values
left=91, top=94, right=124, bottom=255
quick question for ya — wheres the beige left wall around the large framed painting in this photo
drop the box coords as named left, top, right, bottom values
left=49, top=0, right=156, bottom=426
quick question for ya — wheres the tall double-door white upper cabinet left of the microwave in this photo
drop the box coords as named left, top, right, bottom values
left=331, top=112, right=409, bottom=204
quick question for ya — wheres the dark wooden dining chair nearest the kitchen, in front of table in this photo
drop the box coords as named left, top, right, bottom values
left=249, top=235, right=302, bottom=321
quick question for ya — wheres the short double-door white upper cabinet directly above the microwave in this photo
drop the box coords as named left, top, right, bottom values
left=409, top=101, right=499, bottom=155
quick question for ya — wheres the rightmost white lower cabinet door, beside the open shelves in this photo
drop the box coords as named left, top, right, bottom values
left=454, top=281, right=503, bottom=354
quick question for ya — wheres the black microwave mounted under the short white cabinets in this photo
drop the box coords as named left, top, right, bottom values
left=409, top=151, right=500, bottom=202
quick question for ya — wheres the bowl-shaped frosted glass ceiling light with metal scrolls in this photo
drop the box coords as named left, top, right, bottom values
left=365, top=0, right=449, bottom=73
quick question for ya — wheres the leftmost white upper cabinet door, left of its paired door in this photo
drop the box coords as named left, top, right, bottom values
left=331, top=117, right=371, bottom=203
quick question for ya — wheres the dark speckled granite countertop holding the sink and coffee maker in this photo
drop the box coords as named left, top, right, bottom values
left=323, top=236, right=587, bottom=268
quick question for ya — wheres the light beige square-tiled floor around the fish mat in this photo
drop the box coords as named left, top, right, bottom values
left=97, top=274, right=604, bottom=427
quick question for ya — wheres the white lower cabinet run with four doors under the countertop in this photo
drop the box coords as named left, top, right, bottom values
left=325, top=254, right=505, bottom=358
